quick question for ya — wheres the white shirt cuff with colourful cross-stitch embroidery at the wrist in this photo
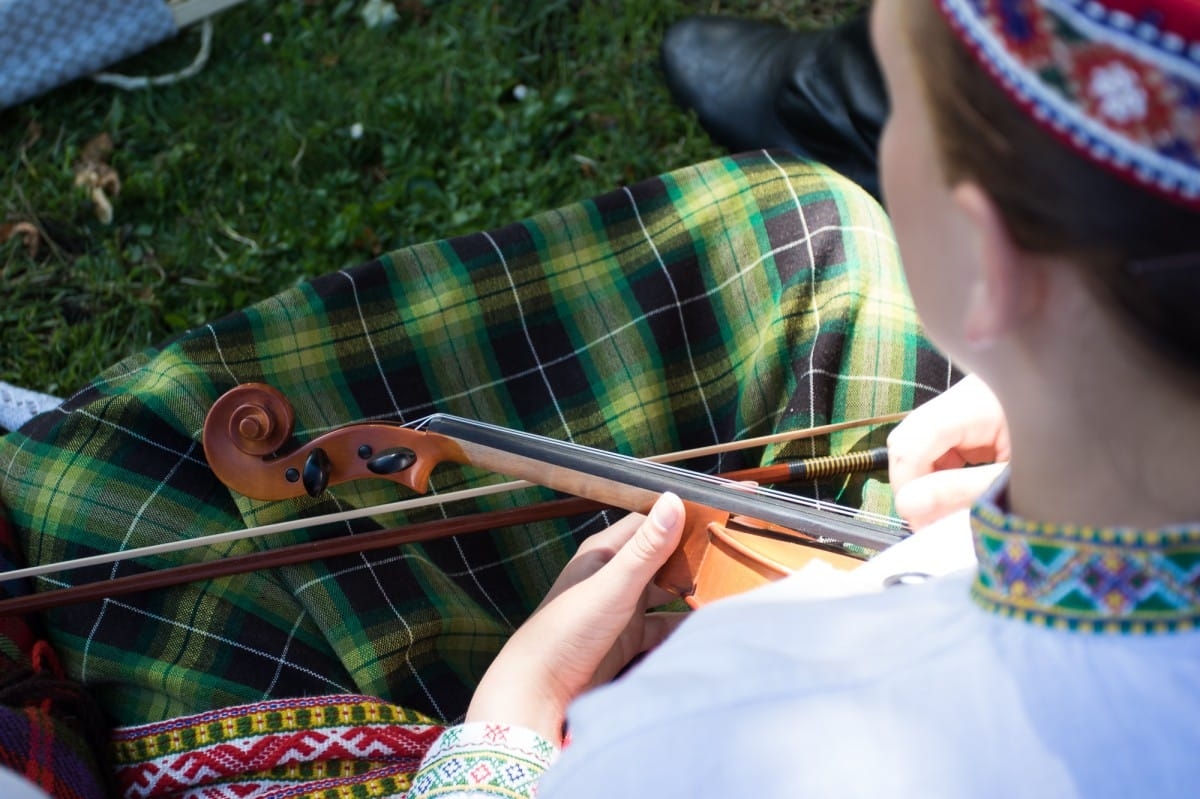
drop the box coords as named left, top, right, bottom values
left=408, top=722, right=558, bottom=799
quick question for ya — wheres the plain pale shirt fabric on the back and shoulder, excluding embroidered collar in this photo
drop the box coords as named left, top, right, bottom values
left=538, top=503, right=1200, bottom=799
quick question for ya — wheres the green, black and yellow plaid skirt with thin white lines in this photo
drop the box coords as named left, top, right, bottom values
left=0, top=152, right=954, bottom=725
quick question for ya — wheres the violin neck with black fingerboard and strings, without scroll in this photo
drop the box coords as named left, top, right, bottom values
left=422, top=414, right=907, bottom=549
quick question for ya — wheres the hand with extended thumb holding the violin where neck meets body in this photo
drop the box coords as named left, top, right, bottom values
left=466, top=493, right=684, bottom=743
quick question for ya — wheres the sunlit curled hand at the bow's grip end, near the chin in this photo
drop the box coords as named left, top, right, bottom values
left=888, top=376, right=1010, bottom=530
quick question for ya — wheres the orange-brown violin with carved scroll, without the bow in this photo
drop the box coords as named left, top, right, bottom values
left=204, top=384, right=906, bottom=607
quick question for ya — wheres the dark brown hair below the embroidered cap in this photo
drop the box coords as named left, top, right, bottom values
left=904, top=0, right=1200, bottom=368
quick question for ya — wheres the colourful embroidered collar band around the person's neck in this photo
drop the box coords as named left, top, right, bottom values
left=971, top=475, right=1200, bottom=633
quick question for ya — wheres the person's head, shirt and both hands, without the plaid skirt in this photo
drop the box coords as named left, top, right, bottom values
left=405, top=0, right=1200, bottom=798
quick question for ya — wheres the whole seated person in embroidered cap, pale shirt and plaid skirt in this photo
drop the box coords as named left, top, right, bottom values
left=9, top=0, right=1200, bottom=797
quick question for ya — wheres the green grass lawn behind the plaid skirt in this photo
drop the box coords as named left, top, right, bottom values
left=0, top=0, right=864, bottom=396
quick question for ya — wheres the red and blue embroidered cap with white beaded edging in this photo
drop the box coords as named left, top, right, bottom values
left=936, top=0, right=1200, bottom=209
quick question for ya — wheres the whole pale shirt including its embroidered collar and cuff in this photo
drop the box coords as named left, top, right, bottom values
left=414, top=480, right=1200, bottom=799
